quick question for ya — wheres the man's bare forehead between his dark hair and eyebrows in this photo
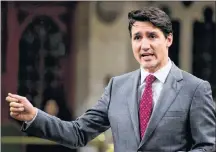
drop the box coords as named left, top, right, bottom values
left=131, top=21, right=162, bottom=34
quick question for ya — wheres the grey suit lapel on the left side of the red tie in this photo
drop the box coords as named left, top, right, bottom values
left=126, top=70, right=140, bottom=143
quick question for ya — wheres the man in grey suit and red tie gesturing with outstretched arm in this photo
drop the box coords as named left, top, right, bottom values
left=6, top=7, right=216, bottom=152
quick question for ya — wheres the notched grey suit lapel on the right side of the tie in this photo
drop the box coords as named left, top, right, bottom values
left=139, top=63, right=183, bottom=148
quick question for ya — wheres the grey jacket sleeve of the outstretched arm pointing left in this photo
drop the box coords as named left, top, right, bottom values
left=21, top=79, right=113, bottom=148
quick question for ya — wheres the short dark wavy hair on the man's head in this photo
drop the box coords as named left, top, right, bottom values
left=128, top=7, right=173, bottom=38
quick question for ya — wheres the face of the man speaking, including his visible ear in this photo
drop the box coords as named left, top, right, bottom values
left=131, top=21, right=173, bottom=73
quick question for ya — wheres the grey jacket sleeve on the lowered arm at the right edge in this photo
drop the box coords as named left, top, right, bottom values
left=189, top=81, right=216, bottom=152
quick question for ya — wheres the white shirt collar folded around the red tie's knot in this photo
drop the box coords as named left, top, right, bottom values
left=141, top=59, right=172, bottom=84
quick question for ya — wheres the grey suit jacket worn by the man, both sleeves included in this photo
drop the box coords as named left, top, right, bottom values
left=22, top=64, right=216, bottom=152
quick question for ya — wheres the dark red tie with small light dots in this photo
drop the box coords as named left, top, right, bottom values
left=139, top=74, right=155, bottom=139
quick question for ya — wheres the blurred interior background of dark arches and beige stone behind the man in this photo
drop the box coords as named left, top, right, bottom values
left=1, top=1, right=216, bottom=152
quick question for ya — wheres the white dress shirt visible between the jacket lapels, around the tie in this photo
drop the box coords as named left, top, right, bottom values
left=138, top=59, right=172, bottom=110
